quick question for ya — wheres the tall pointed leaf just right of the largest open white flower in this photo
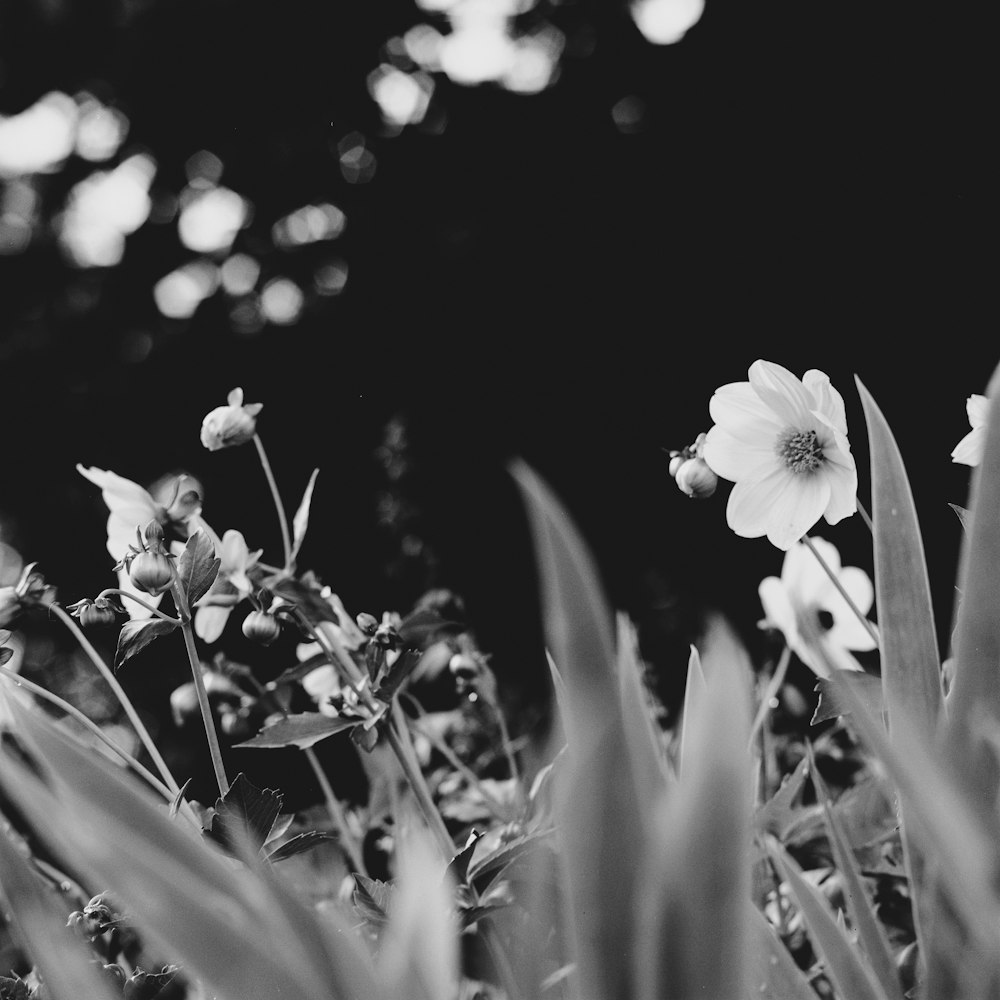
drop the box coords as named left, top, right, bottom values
left=855, top=378, right=940, bottom=733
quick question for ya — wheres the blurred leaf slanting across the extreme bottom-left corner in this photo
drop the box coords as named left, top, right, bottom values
left=0, top=817, right=119, bottom=1000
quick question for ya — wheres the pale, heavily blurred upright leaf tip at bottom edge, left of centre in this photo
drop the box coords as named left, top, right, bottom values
left=379, top=827, right=459, bottom=1000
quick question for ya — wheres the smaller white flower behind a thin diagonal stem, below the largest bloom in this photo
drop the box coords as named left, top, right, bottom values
left=758, top=538, right=876, bottom=677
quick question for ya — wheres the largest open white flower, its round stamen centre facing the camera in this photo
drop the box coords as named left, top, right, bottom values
left=703, top=361, right=858, bottom=550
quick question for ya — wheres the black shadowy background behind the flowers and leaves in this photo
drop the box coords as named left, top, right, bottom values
left=0, top=0, right=997, bottom=800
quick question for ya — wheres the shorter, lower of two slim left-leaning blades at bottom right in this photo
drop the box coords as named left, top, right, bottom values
left=768, top=838, right=889, bottom=1000
